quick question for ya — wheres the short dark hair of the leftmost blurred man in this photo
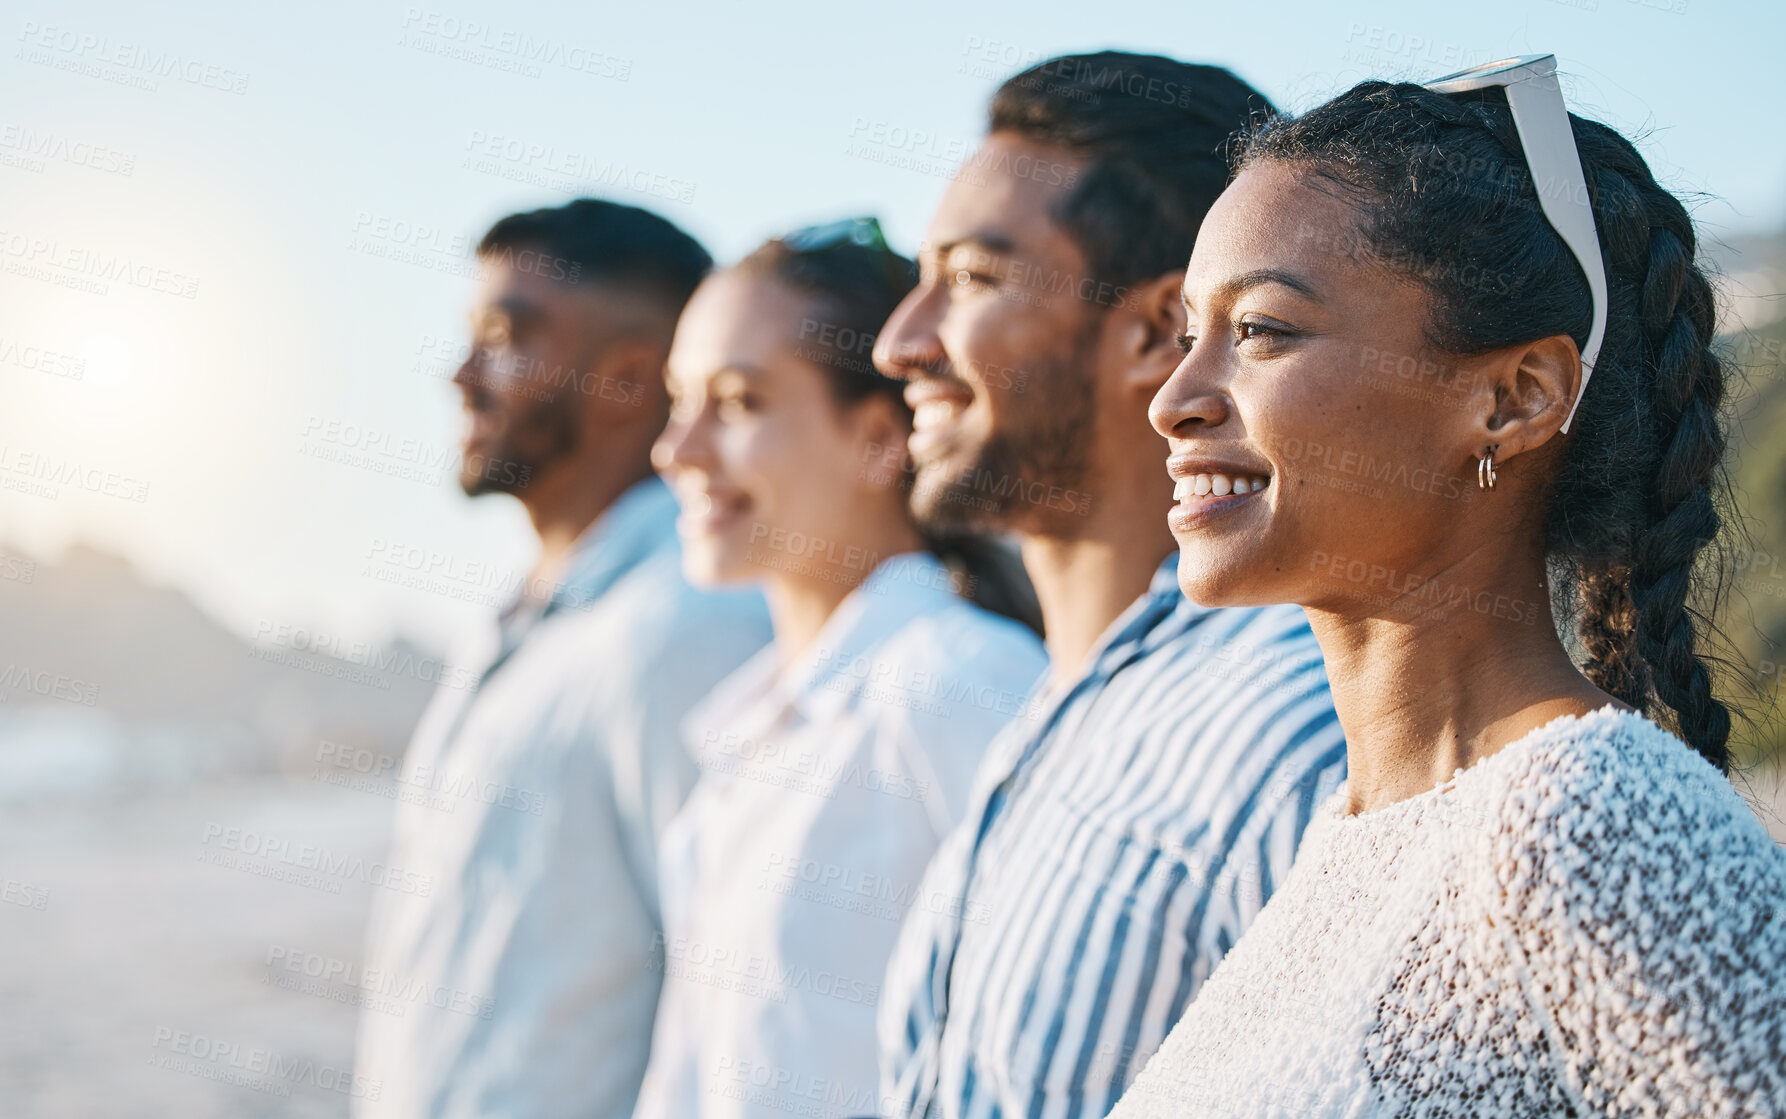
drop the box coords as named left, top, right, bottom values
left=477, top=198, right=713, bottom=312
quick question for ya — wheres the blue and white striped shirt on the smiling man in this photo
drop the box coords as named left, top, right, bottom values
left=879, top=557, right=1345, bottom=1119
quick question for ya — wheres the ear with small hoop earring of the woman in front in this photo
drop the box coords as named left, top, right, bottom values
left=1468, top=334, right=1581, bottom=464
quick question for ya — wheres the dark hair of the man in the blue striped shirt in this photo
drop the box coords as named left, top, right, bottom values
left=991, top=50, right=1273, bottom=284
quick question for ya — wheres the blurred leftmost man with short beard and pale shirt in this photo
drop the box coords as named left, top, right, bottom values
left=354, top=198, right=768, bottom=1119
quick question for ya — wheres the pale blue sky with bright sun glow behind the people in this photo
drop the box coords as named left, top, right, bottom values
left=0, top=0, right=1786, bottom=653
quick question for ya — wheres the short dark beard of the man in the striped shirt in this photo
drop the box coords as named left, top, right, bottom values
left=911, top=330, right=1097, bottom=534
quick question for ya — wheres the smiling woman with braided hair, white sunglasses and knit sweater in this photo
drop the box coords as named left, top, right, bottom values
left=1113, top=61, right=1786, bottom=1119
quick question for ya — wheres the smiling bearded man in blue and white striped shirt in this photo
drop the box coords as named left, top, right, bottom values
left=875, top=52, right=1345, bottom=1119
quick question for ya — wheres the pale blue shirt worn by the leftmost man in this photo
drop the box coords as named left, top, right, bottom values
left=355, top=477, right=770, bottom=1119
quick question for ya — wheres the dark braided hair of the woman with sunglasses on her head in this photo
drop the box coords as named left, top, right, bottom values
left=1239, top=82, right=1731, bottom=769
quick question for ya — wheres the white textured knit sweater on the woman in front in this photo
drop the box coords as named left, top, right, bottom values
left=1111, top=707, right=1786, bottom=1119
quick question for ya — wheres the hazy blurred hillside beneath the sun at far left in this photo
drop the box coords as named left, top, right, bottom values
left=0, top=548, right=438, bottom=801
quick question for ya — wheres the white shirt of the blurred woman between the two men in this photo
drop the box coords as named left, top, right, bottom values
left=636, top=553, right=1045, bottom=1119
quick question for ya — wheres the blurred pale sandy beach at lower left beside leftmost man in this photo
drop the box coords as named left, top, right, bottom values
left=0, top=776, right=389, bottom=1119
